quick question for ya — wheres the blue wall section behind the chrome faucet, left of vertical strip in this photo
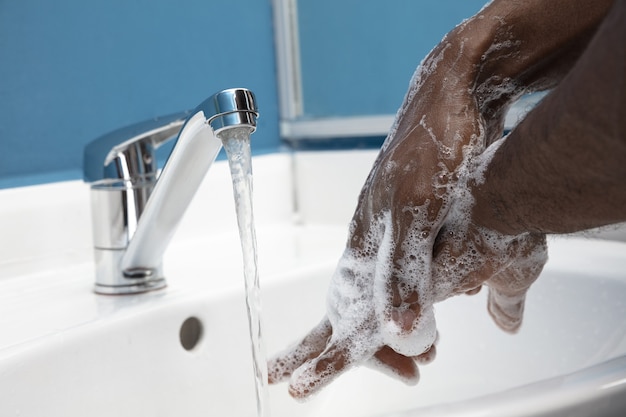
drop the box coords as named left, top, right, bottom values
left=0, top=0, right=279, bottom=188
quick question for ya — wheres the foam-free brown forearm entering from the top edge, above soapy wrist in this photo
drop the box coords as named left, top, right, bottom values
left=453, top=0, right=612, bottom=137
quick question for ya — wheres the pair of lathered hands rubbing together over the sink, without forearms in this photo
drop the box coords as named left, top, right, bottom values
left=268, top=22, right=546, bottom=398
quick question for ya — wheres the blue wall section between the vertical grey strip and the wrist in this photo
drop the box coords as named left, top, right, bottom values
left=298, top=0, right=486, bottom=117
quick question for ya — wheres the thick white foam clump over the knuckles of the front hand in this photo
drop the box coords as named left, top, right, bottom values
left=327, top=212, right=436, bottom=362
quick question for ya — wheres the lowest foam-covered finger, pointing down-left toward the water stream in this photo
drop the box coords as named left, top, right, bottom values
left=289, top=335, right=375, bottom=399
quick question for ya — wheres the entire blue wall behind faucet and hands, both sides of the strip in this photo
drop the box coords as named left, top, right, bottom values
left=0, top=0, right=484, bottom=188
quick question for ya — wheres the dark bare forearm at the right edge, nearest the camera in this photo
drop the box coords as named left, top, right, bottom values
left=473, top=2, right=626, bottom=234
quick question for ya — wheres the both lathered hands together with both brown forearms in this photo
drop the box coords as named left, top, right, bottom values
left=268, top=0, right=626, bottom=398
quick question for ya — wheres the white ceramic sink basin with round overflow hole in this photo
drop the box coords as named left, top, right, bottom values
left=0, top=151, right=626, bottom=417
